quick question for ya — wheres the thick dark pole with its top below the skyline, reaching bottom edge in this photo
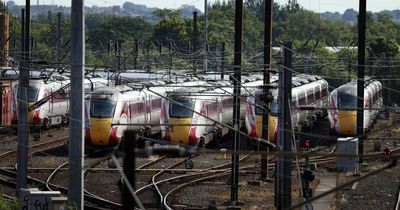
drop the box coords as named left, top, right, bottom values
left=275, top=42, right=292, bottom=210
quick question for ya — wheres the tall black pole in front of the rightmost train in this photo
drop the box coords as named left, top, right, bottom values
left=357, top=0, right=367, bottom=163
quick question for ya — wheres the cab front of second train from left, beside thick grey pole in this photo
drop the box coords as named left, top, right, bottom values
left=85, top=89, right=121, bottom=147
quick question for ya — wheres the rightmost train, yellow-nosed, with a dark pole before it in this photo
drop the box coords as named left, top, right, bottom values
left=328, top=78, right=383, bottom=137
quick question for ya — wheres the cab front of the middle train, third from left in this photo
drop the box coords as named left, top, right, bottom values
left=160, top=93, right=205, bottom=146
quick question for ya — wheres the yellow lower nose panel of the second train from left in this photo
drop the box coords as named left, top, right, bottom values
left=90, top=118, right=112, bottom=146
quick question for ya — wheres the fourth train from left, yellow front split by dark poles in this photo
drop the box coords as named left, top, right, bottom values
left=245, top=74, right=329, bottom=145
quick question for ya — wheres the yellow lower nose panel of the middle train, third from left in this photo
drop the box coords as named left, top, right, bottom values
left=170, top=118, right=192, bottom=145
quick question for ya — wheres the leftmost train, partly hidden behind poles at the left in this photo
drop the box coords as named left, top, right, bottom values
left=11, top=75, right=107, bottom=128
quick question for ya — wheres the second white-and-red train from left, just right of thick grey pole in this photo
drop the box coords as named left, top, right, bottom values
left=85, top=78, right=211, bottom=148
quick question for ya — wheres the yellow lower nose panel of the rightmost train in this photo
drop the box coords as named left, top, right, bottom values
left=338, top=111, right=357, bottom=136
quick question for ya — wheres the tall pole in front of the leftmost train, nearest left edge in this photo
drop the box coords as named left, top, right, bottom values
left=17, top=6, right=30, bottom=200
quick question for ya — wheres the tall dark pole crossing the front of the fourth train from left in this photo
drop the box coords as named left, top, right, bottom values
left=260, top=0, right=272, bottom=180
